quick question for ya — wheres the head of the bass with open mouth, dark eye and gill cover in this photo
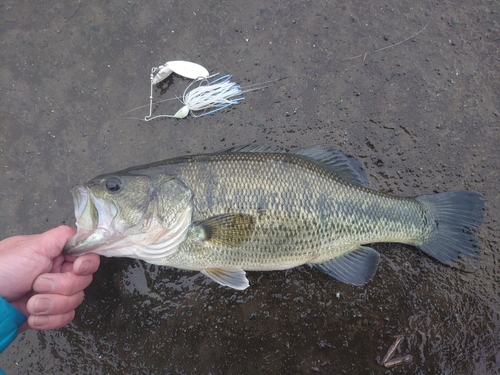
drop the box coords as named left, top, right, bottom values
left=65, top=171, right=192, bottom=263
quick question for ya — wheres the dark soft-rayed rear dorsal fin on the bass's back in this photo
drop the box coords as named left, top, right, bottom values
left=292, top=145, right=369, bottom=187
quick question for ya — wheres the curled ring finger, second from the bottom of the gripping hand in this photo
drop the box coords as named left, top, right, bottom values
left=26, top=292, right=83, bottom=315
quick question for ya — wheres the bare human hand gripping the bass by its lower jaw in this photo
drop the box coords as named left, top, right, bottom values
left=0, top=225, right=100, bottom=332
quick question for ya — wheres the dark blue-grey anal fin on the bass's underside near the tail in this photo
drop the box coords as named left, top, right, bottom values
left=314, top=246, right=380, bottom=285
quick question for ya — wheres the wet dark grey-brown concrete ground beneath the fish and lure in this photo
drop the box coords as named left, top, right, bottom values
left=0, top=0, right=500, bottom=374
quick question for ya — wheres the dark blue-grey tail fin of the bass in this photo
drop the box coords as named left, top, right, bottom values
left=415, top=191, right=484, bottom=263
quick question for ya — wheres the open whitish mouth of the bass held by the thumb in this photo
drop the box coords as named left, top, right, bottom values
left=64, top=185, right=118, bottom=255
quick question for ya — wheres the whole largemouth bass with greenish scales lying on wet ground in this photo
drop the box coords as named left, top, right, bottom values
left=64, top=145, right=484, bottom=290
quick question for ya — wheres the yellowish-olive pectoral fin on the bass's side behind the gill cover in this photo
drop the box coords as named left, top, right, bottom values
left=195, top=214, right=255, bottom=248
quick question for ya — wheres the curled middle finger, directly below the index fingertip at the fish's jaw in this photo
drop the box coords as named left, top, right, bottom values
left=33, top=272, right=92, bottom=296
